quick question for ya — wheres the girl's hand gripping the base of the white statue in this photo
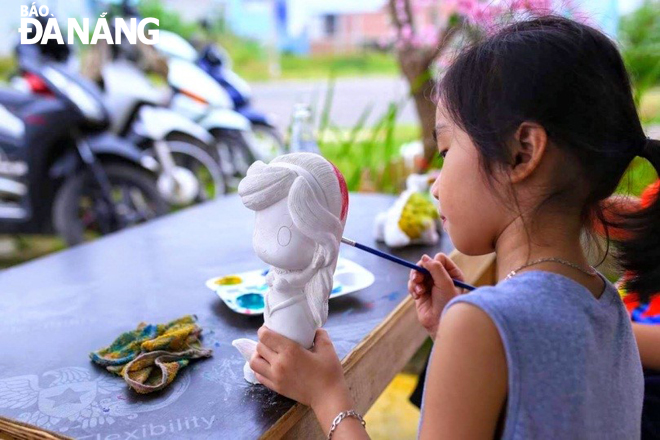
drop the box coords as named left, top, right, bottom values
left=250, top=326, right=350, bottom=411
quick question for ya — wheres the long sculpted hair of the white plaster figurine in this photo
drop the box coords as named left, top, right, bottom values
left=238, top=153, right=348, bottom=327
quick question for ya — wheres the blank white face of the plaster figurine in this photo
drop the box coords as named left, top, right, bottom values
left=252, top=197, right=316, bottom=270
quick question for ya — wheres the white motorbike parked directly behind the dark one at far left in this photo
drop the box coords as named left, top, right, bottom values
left=14, top=26, right=226, bottom=207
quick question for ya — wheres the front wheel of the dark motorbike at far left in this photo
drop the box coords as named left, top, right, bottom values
left=53, top=164, right=169, bottom=246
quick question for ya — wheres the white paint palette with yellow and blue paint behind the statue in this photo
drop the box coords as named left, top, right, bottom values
left=206, top=257, right=375, bottom=315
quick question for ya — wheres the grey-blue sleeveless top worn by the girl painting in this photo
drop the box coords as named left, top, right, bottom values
left=422, top=271, right=644, bottom=440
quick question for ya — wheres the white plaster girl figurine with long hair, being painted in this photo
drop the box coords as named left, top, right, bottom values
left=232, top=153, right=348, bottom=383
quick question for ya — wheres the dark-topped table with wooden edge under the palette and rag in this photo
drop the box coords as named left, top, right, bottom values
left=0, top=194, right=493, bottom=440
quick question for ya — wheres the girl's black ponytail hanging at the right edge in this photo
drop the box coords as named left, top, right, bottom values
left=618, top=139, right=660, bottom=303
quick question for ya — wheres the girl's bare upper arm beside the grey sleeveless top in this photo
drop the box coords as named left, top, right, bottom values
left=419, top=303, right=508, bottom=440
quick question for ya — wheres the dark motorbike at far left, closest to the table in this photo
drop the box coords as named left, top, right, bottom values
left=0, top=61, right=168, bottom=245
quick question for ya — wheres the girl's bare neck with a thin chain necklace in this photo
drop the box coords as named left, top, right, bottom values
left=495, top=215, right=602, bottom=297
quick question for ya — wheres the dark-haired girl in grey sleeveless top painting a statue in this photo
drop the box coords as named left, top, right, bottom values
left=250, top=16, right=660, bottom=439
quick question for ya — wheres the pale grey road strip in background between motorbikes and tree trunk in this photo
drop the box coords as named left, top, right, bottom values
left=252, top=77, right=417, bottom=130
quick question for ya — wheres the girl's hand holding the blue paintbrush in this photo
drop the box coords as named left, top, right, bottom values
left=408, top=254, right=465, bottom=340
